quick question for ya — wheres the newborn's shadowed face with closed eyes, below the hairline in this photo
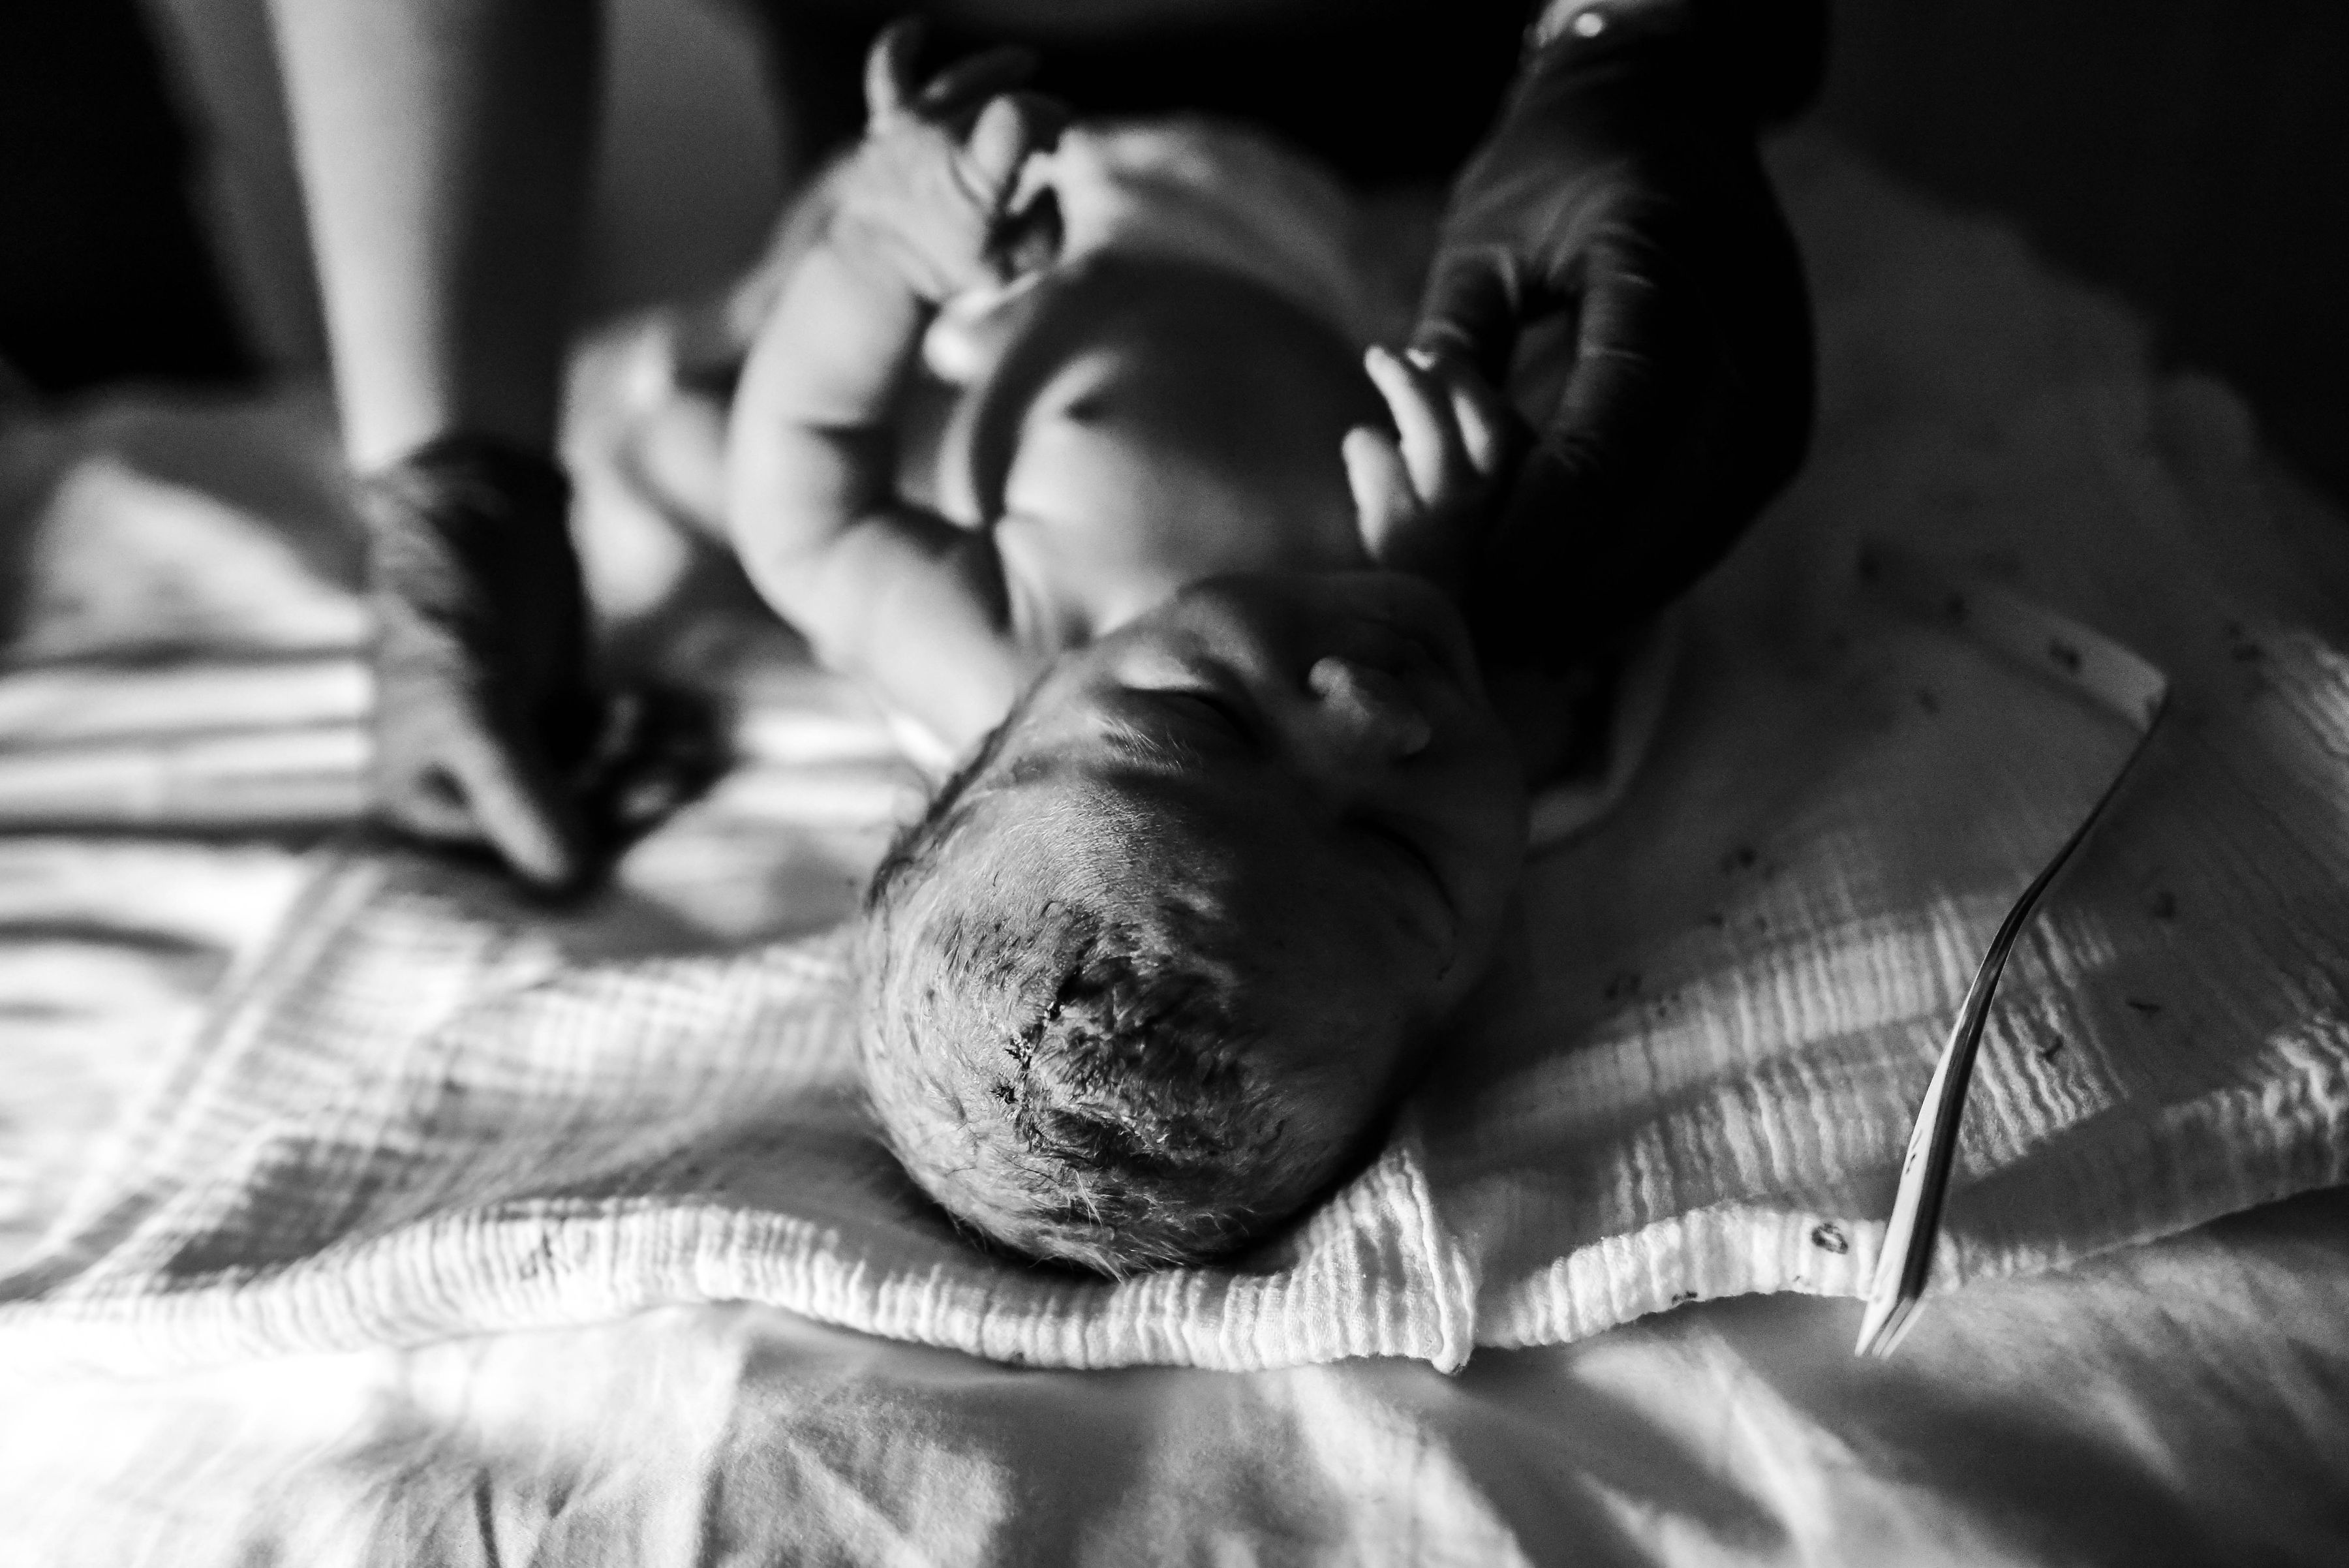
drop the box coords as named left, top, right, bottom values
left=989, top=570, right=1527, bottom=1051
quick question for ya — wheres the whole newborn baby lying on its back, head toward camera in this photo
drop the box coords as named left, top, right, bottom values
left=728, top=31, right=1558, bottom=1274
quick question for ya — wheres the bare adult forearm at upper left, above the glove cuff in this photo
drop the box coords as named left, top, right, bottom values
left=273, top=0, right=599, bottom=469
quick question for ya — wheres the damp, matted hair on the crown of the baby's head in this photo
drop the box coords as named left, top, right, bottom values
left=857, top=716, right=1370, bottom=1277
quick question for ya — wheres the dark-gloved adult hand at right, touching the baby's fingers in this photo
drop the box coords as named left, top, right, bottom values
left=1417, top=0, right=1823, bottom=669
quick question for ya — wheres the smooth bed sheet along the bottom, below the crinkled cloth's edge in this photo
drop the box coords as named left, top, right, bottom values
left=0, top=1192, right=2349, bottom=1568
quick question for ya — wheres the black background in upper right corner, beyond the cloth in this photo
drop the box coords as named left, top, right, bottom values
left=1820, top=0, right=2349, bottom=502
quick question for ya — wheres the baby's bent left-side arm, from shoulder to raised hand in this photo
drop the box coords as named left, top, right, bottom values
left=728, top=28, right=1062, bottom=746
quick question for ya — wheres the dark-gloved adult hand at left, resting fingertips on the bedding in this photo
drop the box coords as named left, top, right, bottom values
left=361, top=437, right=714, bottom=895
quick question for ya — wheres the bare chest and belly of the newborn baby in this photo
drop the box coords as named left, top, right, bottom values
left=935, top=251, right=1381, bottom=657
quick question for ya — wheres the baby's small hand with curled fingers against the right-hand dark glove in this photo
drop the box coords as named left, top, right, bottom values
left=1343, top=347, right=1524, bottom=587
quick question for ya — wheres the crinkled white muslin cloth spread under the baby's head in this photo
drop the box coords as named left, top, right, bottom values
left=14, top=138, right=2349, bottom=1366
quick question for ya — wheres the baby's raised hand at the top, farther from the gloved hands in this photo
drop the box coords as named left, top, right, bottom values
left=831, top=21, right=1066, bottom=303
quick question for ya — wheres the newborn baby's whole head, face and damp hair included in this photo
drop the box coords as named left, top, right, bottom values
left=860, top=573, right=1524, bottom=1274
